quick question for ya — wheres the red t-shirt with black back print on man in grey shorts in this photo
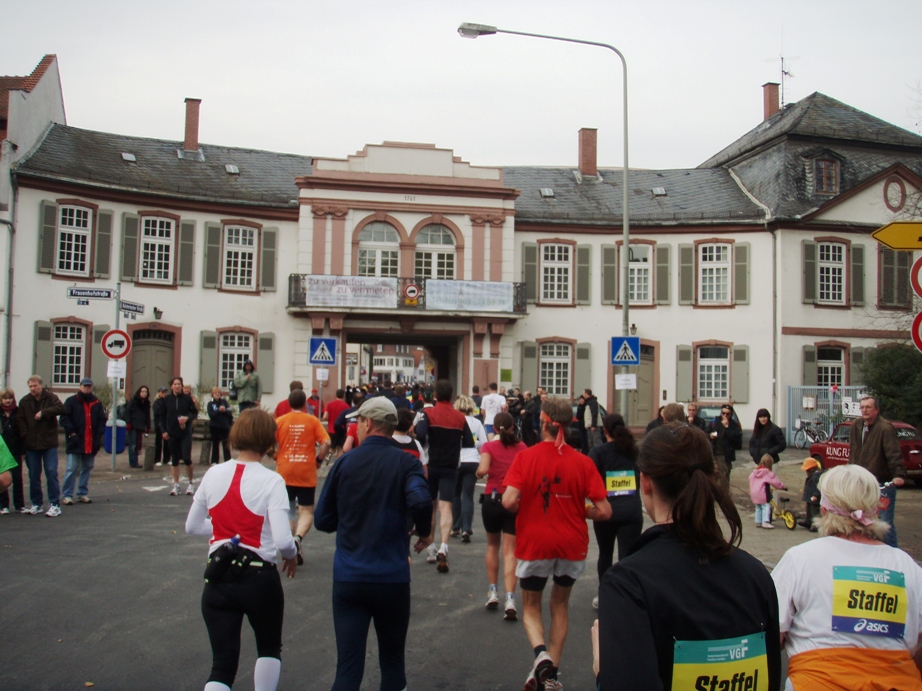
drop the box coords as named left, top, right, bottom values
left=506, top=441, right=607, bottom=561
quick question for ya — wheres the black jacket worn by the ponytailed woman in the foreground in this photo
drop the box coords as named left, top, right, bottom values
left=599, top=526, right=781, bottom=691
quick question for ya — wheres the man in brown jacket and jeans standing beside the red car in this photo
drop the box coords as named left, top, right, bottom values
left=848, top=396, right=906, bottom=547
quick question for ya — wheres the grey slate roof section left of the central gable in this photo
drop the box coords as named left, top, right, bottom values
left=15, top=125, right=311, bottom=208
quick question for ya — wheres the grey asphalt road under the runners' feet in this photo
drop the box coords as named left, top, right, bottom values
left=0, top=451, right=922, bottom=691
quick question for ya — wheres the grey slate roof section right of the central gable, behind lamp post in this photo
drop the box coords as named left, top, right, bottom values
left=503, top=167, right=765, bottom=225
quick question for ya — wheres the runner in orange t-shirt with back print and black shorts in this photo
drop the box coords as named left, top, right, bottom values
left=275, top=390, right=330, bottom=566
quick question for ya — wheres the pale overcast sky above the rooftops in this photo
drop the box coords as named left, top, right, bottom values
left=0, top=0, right=922, bottom=168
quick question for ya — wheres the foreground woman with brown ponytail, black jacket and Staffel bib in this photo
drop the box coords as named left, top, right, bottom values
left=593, top=423, right=781, bottom=691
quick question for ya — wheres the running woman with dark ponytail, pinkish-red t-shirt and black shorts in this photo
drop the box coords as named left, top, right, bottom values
left=477, top=413, right=528, bottom=621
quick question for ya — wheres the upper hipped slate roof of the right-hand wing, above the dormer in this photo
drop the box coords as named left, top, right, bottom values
left=698, top=91, right=922, bottom=168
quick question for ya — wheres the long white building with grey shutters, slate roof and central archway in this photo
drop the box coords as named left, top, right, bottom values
left=0, top=62, right=922, bottom=436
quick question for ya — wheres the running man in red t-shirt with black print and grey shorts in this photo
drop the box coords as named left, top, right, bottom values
left=503, top=399, right=611, bottom=691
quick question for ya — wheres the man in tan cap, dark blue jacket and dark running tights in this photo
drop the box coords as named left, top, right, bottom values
left=314, top=396, right=432, bottom=691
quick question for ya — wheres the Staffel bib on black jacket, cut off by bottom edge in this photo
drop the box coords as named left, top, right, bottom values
left=672, top=631, right=768, bottom=691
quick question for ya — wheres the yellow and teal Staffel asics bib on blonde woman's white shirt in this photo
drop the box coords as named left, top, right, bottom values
left=832, top=566, right=908, bottom=638
